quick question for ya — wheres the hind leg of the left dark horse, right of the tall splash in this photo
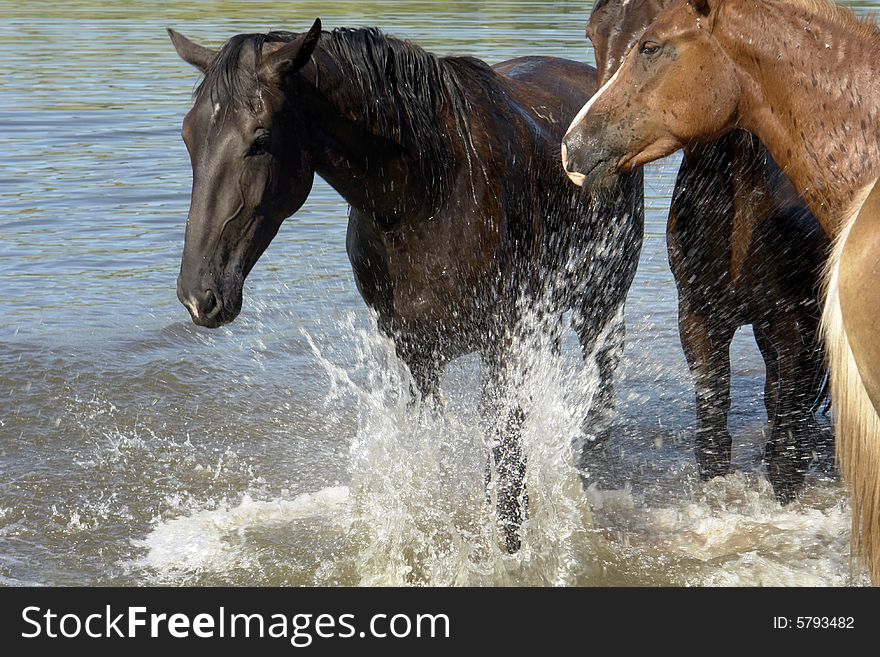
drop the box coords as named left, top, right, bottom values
left=572, top=306, right=626, bottom=449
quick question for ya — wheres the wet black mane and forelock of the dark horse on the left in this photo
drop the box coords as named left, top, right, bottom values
left=195, top=28, right=500, bottom=191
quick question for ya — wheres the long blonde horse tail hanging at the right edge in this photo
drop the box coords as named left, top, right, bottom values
left=822, top=204, right=880, bottom=586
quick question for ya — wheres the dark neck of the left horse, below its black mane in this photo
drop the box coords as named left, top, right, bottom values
left=295, top=46, right=450, bottom=219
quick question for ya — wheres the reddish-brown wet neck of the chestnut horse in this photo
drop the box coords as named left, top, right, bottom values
left=715, top=0, right=880, bottom=235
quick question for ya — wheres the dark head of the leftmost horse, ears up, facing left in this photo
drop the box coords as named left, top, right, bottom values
left=168, top=20, right=321, bottom=328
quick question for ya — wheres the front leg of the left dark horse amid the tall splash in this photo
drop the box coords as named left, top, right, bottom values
left=481, top=353, right=528, bottom=554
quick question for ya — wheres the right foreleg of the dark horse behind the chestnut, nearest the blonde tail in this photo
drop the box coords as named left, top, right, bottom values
left=764, top=309, right=824, bottom=504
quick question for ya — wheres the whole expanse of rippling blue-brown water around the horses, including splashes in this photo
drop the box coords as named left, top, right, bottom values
left=0, top=0, right=869, bottom=585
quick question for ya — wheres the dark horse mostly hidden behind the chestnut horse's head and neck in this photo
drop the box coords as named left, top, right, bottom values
left=587, top=0, right=832, bottom=502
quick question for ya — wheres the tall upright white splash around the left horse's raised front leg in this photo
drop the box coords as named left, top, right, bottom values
left=302, top=312, right=593, bottom=585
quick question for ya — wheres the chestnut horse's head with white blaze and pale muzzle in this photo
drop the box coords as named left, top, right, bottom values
left=562, top=0, right=741, bottom=188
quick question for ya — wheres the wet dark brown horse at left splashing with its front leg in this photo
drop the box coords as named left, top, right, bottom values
left=170, top=21, right=643, bottom=551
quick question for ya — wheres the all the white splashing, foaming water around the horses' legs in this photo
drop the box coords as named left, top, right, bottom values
left=128, top=304, right=865, bottom=586
